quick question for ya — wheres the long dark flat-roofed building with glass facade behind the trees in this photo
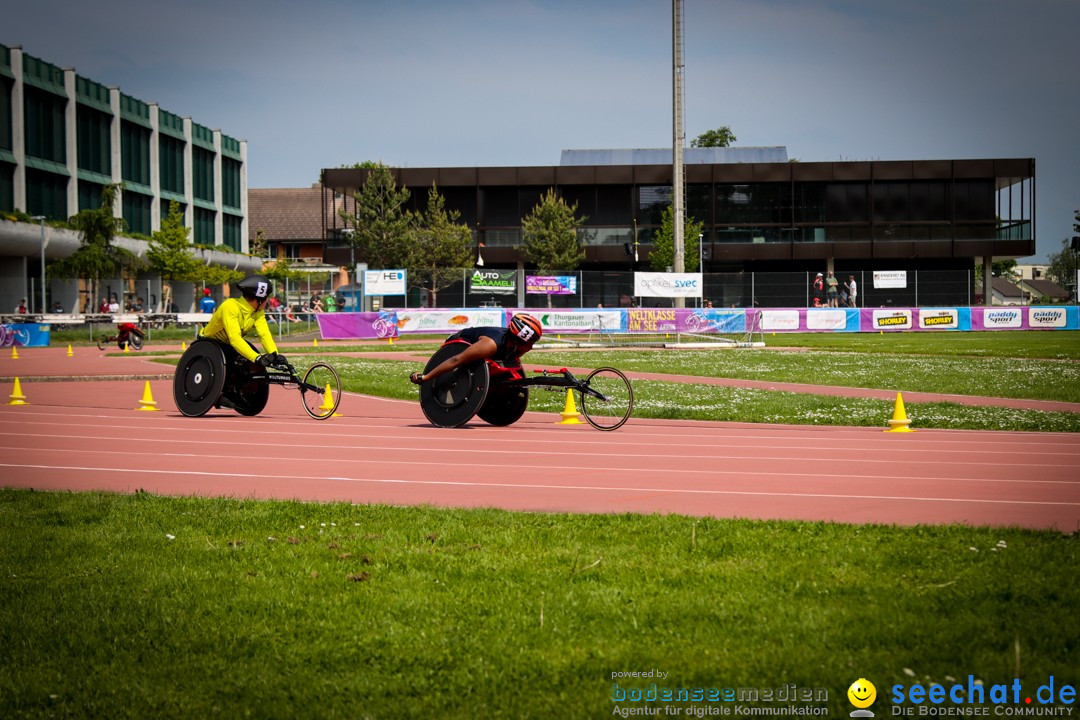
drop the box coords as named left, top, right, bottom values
left=323, top=148, right=1036, bottom=302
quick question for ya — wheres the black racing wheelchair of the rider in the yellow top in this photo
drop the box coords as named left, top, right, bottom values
left=173, top=338, right=341, bottom=420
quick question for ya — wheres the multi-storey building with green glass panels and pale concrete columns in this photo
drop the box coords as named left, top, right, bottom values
left=0, top=45, right=247, bottom=249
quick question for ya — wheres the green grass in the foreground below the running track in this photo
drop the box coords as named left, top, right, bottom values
left=0, top=490, right=1080, bottom=718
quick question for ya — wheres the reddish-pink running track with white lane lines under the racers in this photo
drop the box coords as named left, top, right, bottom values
left=0, top=348, right=1080, bottom=532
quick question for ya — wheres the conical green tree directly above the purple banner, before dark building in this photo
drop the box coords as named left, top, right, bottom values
left=522, top=188, right=589, bottom=274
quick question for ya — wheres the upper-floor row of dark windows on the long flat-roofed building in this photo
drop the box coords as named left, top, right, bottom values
left=388, top=180, right=995, bottom=227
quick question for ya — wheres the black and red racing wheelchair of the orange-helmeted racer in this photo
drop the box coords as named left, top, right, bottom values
left=420, top=340, right=634, bottom=430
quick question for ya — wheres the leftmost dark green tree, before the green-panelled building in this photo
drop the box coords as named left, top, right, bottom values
left=50, top=185, right=141, bottom=303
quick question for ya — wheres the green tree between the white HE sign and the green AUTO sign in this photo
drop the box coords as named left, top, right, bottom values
left=405, top=184, right=473, bottom=308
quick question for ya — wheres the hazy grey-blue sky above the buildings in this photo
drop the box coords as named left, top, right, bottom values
left=0, top=0, right=1080, bottom=257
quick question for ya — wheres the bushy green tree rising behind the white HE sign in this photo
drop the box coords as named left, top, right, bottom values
left=339, top=165, right=415, bottom=270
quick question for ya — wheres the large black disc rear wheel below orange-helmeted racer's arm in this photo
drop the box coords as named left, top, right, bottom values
left=420, top=342, right=491, bottom=427
